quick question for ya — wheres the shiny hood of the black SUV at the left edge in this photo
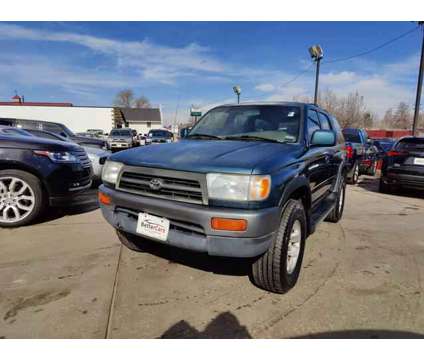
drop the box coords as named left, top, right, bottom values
left=0, top=135, right=81, bottom=152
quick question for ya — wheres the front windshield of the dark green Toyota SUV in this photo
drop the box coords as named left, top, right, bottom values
left=189, top=105, right=300, bottom=142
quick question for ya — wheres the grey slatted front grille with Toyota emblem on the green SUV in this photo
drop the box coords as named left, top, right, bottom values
left=117, top=168, right=207, bottom=204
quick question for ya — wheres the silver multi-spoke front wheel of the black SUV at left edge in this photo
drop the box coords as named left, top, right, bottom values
left=0, top=169, right=45, bottom=227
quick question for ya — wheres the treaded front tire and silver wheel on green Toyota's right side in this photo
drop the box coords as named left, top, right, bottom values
left=252, top=199, right=307, bottom=294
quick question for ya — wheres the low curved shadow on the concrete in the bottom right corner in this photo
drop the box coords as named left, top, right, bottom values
left=295, top=329, right=424, bottom=339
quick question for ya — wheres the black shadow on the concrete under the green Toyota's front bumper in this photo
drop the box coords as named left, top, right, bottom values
left=129, top=239, right=252, bottom=276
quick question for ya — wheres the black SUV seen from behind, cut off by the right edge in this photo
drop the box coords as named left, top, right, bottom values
left=380, top=137, right=424, bottom=193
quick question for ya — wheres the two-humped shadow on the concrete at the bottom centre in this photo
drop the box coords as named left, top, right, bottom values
left=160, top=311, right=252, bottom=339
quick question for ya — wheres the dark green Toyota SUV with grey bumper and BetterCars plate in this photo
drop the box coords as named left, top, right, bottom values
left=99, top=102, right=345, bottom=293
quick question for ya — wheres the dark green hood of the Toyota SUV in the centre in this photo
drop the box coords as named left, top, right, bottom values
left=110, top=140, right=303, bottom=174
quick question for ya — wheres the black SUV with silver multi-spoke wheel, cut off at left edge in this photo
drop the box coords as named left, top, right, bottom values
left=0, top=129, right=92, bottom=227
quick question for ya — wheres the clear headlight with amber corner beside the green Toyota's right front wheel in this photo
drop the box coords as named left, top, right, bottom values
left=206, top=174, right=271, bottom=201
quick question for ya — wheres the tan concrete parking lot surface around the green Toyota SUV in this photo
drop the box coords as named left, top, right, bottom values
left=0, top=178, right=424, bottom=338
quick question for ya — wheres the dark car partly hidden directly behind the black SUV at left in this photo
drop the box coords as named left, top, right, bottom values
left=4, top=119, right=107, bottom=150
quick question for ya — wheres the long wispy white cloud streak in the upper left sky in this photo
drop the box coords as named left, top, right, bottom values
left=0, top=24, right=224, bottom=84
